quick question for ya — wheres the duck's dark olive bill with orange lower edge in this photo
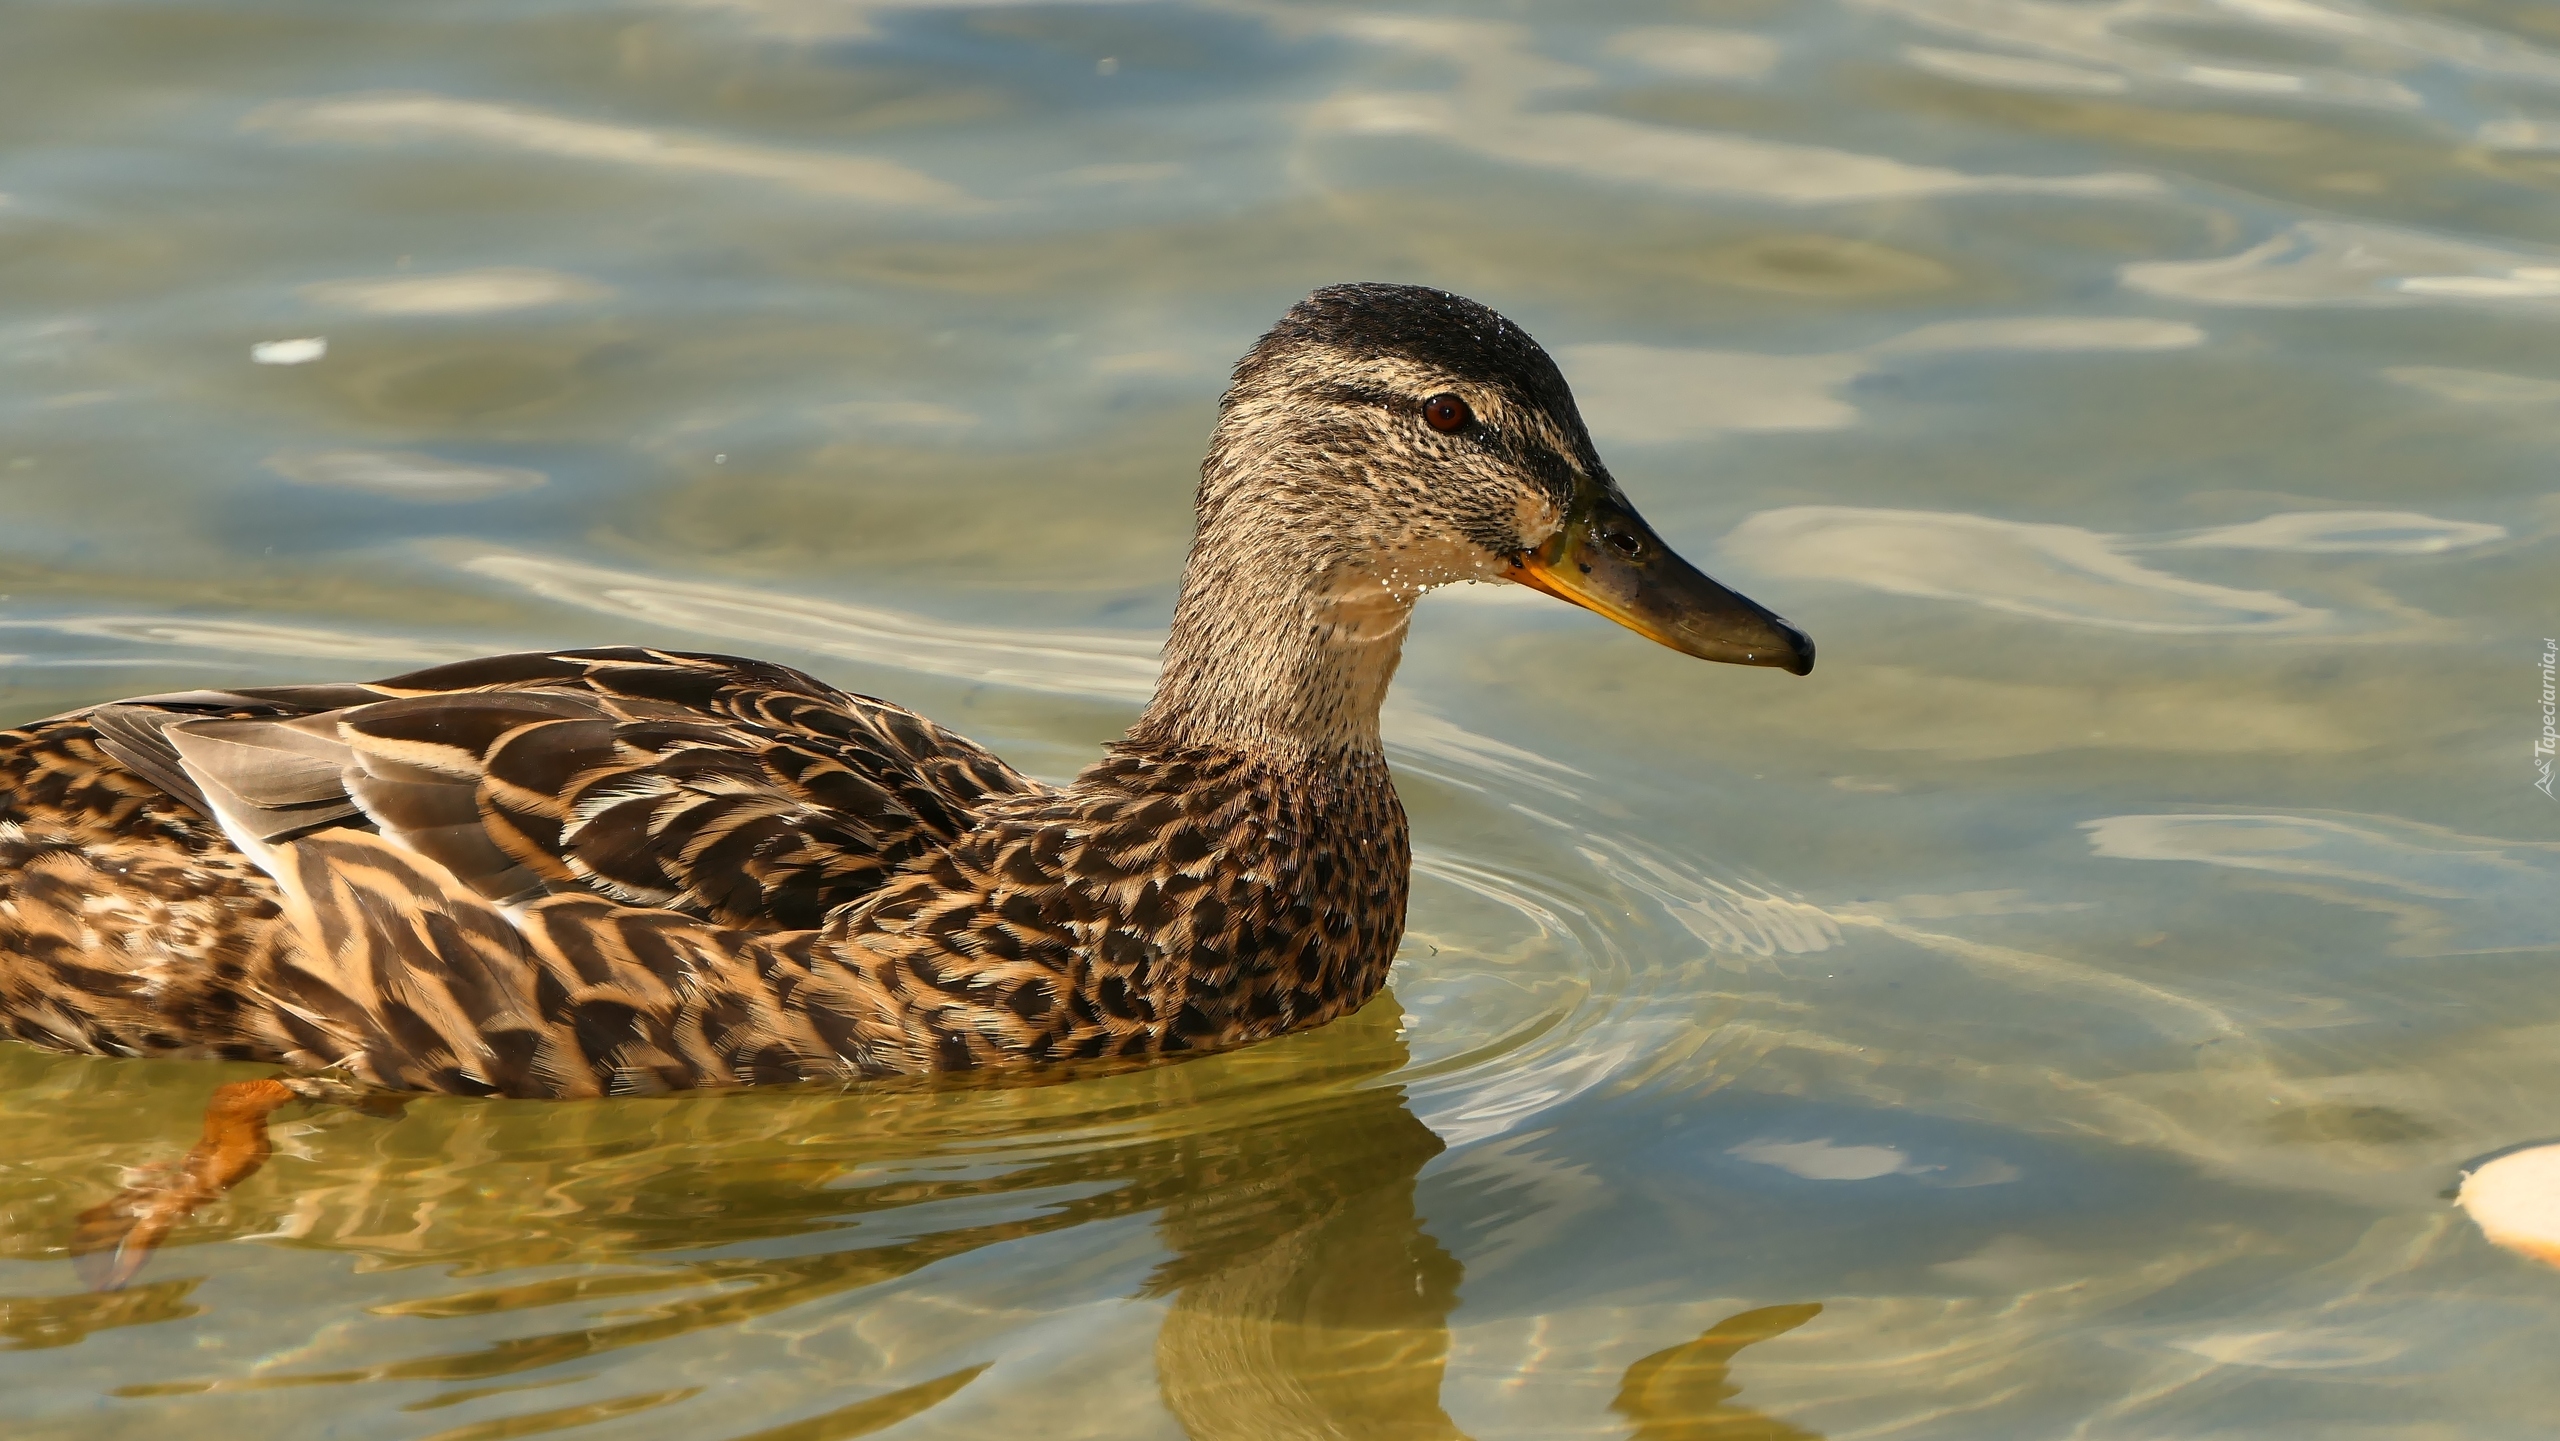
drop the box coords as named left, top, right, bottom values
left=1510, top=494, right=1812, bottom=676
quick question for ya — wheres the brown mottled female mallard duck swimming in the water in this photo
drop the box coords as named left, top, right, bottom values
left=0, top=284, right=1812, bottom=1113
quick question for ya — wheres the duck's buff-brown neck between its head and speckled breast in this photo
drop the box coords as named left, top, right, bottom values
left=1129, top=514, right=1413, bottom=765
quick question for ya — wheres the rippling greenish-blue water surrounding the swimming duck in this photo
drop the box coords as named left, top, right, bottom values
left=0, top=0, right=2560, bottom=1441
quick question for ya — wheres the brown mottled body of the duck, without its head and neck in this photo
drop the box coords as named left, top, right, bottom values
left=0, top=650, right=1408, bottom=1095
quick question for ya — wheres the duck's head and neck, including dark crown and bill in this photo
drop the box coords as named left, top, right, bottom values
left=1149, top=284, right=1812, bottom=745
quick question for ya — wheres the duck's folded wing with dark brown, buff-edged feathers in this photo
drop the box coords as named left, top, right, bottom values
left=92, top=648, right=1039, bottom=929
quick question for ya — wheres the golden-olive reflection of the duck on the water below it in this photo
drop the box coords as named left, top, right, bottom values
left=24, top=996, right=1820, bottom=1441
